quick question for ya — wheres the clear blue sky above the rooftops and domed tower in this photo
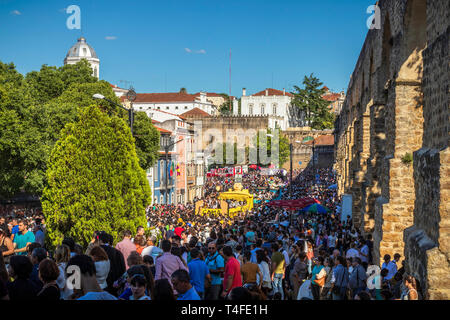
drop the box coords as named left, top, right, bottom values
left=0, top=0, right=375, bottom=96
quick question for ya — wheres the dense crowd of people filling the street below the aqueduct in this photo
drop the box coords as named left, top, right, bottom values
left=0, top=168, right=422, bottom=301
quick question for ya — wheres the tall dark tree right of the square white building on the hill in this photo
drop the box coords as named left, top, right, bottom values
left=292, top=74, right=334, bottom=130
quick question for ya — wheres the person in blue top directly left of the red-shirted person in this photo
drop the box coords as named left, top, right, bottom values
left=205, top=242, right=225, bottom=300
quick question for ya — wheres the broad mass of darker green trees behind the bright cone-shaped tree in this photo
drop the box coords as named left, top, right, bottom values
left=0, top=60, right=159, bottom=198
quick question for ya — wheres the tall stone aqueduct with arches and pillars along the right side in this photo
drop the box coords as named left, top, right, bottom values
left=335, top=0, right=450, bottom=299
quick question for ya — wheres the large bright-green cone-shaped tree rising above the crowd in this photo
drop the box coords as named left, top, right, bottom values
left=42, top=105, right=151, bottom=247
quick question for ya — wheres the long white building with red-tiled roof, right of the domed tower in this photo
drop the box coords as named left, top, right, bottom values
left=128, top=92, right=217, bottom=115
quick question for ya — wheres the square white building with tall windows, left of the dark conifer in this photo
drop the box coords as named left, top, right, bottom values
left=237, top=88, right=292, bottom=131
